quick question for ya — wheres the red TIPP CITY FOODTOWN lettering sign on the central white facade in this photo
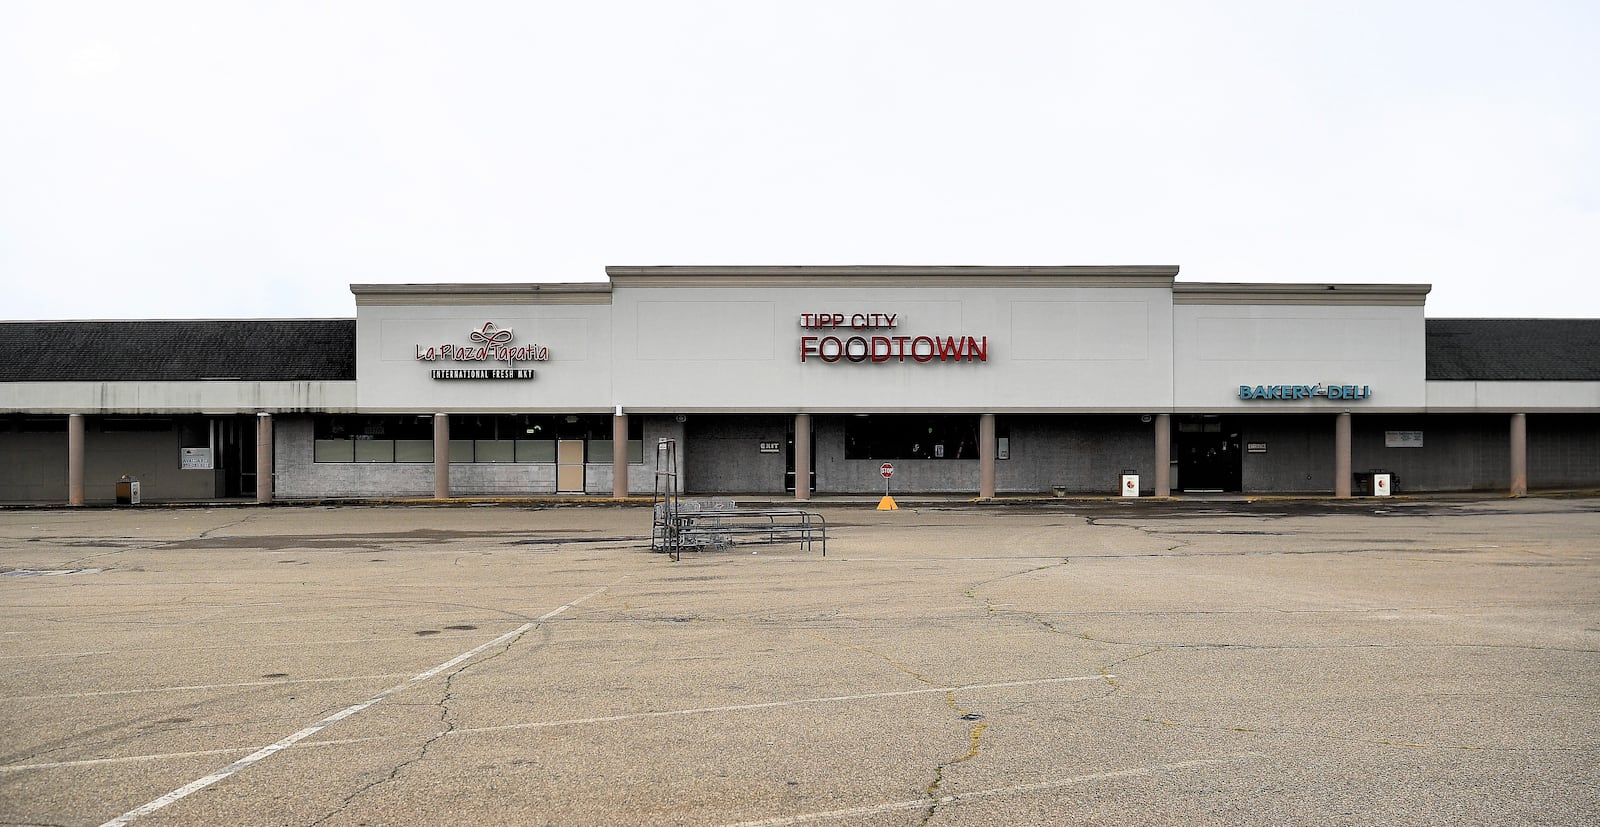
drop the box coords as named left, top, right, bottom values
left=800, top=314, right=989, bottom=365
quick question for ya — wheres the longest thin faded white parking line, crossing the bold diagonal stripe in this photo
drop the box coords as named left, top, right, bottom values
left=0, top=675, right=1117, bottom=774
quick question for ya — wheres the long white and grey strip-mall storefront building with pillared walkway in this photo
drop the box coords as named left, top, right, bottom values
left=0, top=266, right=1600, bottom=504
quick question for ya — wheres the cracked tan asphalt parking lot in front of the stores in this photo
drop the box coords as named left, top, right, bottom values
left=0, top=497, right=1600, bottom=827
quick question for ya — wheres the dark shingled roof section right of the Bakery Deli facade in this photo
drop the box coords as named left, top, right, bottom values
left=1427, top=318, right=1600, bottom=382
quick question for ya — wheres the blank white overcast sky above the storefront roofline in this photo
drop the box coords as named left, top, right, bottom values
left=0, top=0, right=1600, bottom=320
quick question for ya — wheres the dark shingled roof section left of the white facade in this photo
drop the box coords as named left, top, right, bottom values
left=0, top=318, right=355, bottom=382
